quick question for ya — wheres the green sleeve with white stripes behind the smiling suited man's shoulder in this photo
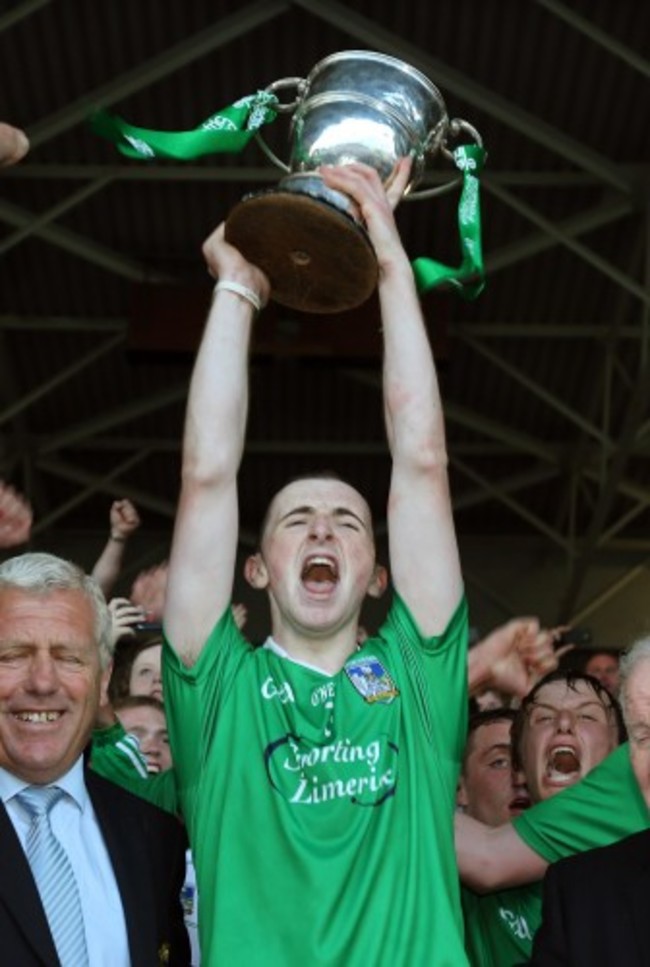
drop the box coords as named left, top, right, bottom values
left=90, top=722, right=179, bottom=814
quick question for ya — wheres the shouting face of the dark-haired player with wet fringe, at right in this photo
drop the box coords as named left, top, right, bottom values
left=521, top=681, right=618, bottom=802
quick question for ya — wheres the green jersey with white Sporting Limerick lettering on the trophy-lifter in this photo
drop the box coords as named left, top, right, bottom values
left=163, top=599, right=467, bottom=967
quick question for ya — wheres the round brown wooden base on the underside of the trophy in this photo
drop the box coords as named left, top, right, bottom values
left=226, top=179, right=378, bottom=314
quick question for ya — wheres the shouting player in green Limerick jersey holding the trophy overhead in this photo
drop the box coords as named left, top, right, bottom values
left=163, top=162, right=467, bottom=967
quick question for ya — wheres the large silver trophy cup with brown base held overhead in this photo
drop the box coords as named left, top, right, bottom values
left=226, top=50, right=481, bottom=313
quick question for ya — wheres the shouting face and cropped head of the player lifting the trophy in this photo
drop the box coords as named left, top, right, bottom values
left=258, top=478, right=375, bottom=634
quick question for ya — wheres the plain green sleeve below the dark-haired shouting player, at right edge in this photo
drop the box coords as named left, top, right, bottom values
left=513, top=742, right=650, bottom=863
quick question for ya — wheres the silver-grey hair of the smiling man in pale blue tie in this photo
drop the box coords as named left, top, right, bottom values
left=0, top=552, right=113, bottom=669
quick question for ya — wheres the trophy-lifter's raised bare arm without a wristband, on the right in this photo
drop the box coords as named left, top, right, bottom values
left=318, top=159, right=462, bottom=636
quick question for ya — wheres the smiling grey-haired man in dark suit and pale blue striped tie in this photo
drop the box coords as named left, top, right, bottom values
left=0, top=554, right=189, bottom=967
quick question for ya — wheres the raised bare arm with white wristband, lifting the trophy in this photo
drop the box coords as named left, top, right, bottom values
left=164, top=226, right=269, bottom=664
